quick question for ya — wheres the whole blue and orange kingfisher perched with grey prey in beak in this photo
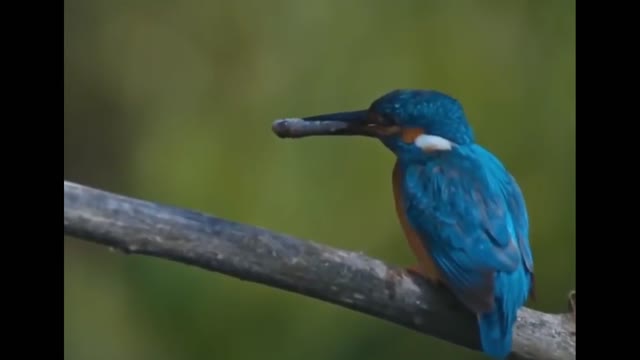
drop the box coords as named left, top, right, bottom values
left=274, top=89, right=535, bottom=359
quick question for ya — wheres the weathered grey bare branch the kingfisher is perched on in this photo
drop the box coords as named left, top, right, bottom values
left=64, top=181, right=575, bottom=360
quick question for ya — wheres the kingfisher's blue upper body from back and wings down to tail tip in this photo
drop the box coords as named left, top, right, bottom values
left=396, top=145, right=533, bottom=357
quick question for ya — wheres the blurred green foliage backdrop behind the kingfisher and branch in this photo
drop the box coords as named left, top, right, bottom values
left=64, top=0, right=575, bottom=360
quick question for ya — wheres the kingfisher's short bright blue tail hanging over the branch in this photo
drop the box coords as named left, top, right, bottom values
left=478, top=268, right=531, bottom=359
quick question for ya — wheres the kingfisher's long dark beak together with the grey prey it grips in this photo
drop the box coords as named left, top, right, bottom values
left=273, top=110, right=397, bottom=138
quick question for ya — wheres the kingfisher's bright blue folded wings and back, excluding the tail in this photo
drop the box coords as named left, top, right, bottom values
left=403, top=146, right=532, bottom=312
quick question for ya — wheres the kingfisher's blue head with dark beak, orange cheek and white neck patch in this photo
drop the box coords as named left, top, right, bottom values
left=278, top=90, right=474, bottom=160
